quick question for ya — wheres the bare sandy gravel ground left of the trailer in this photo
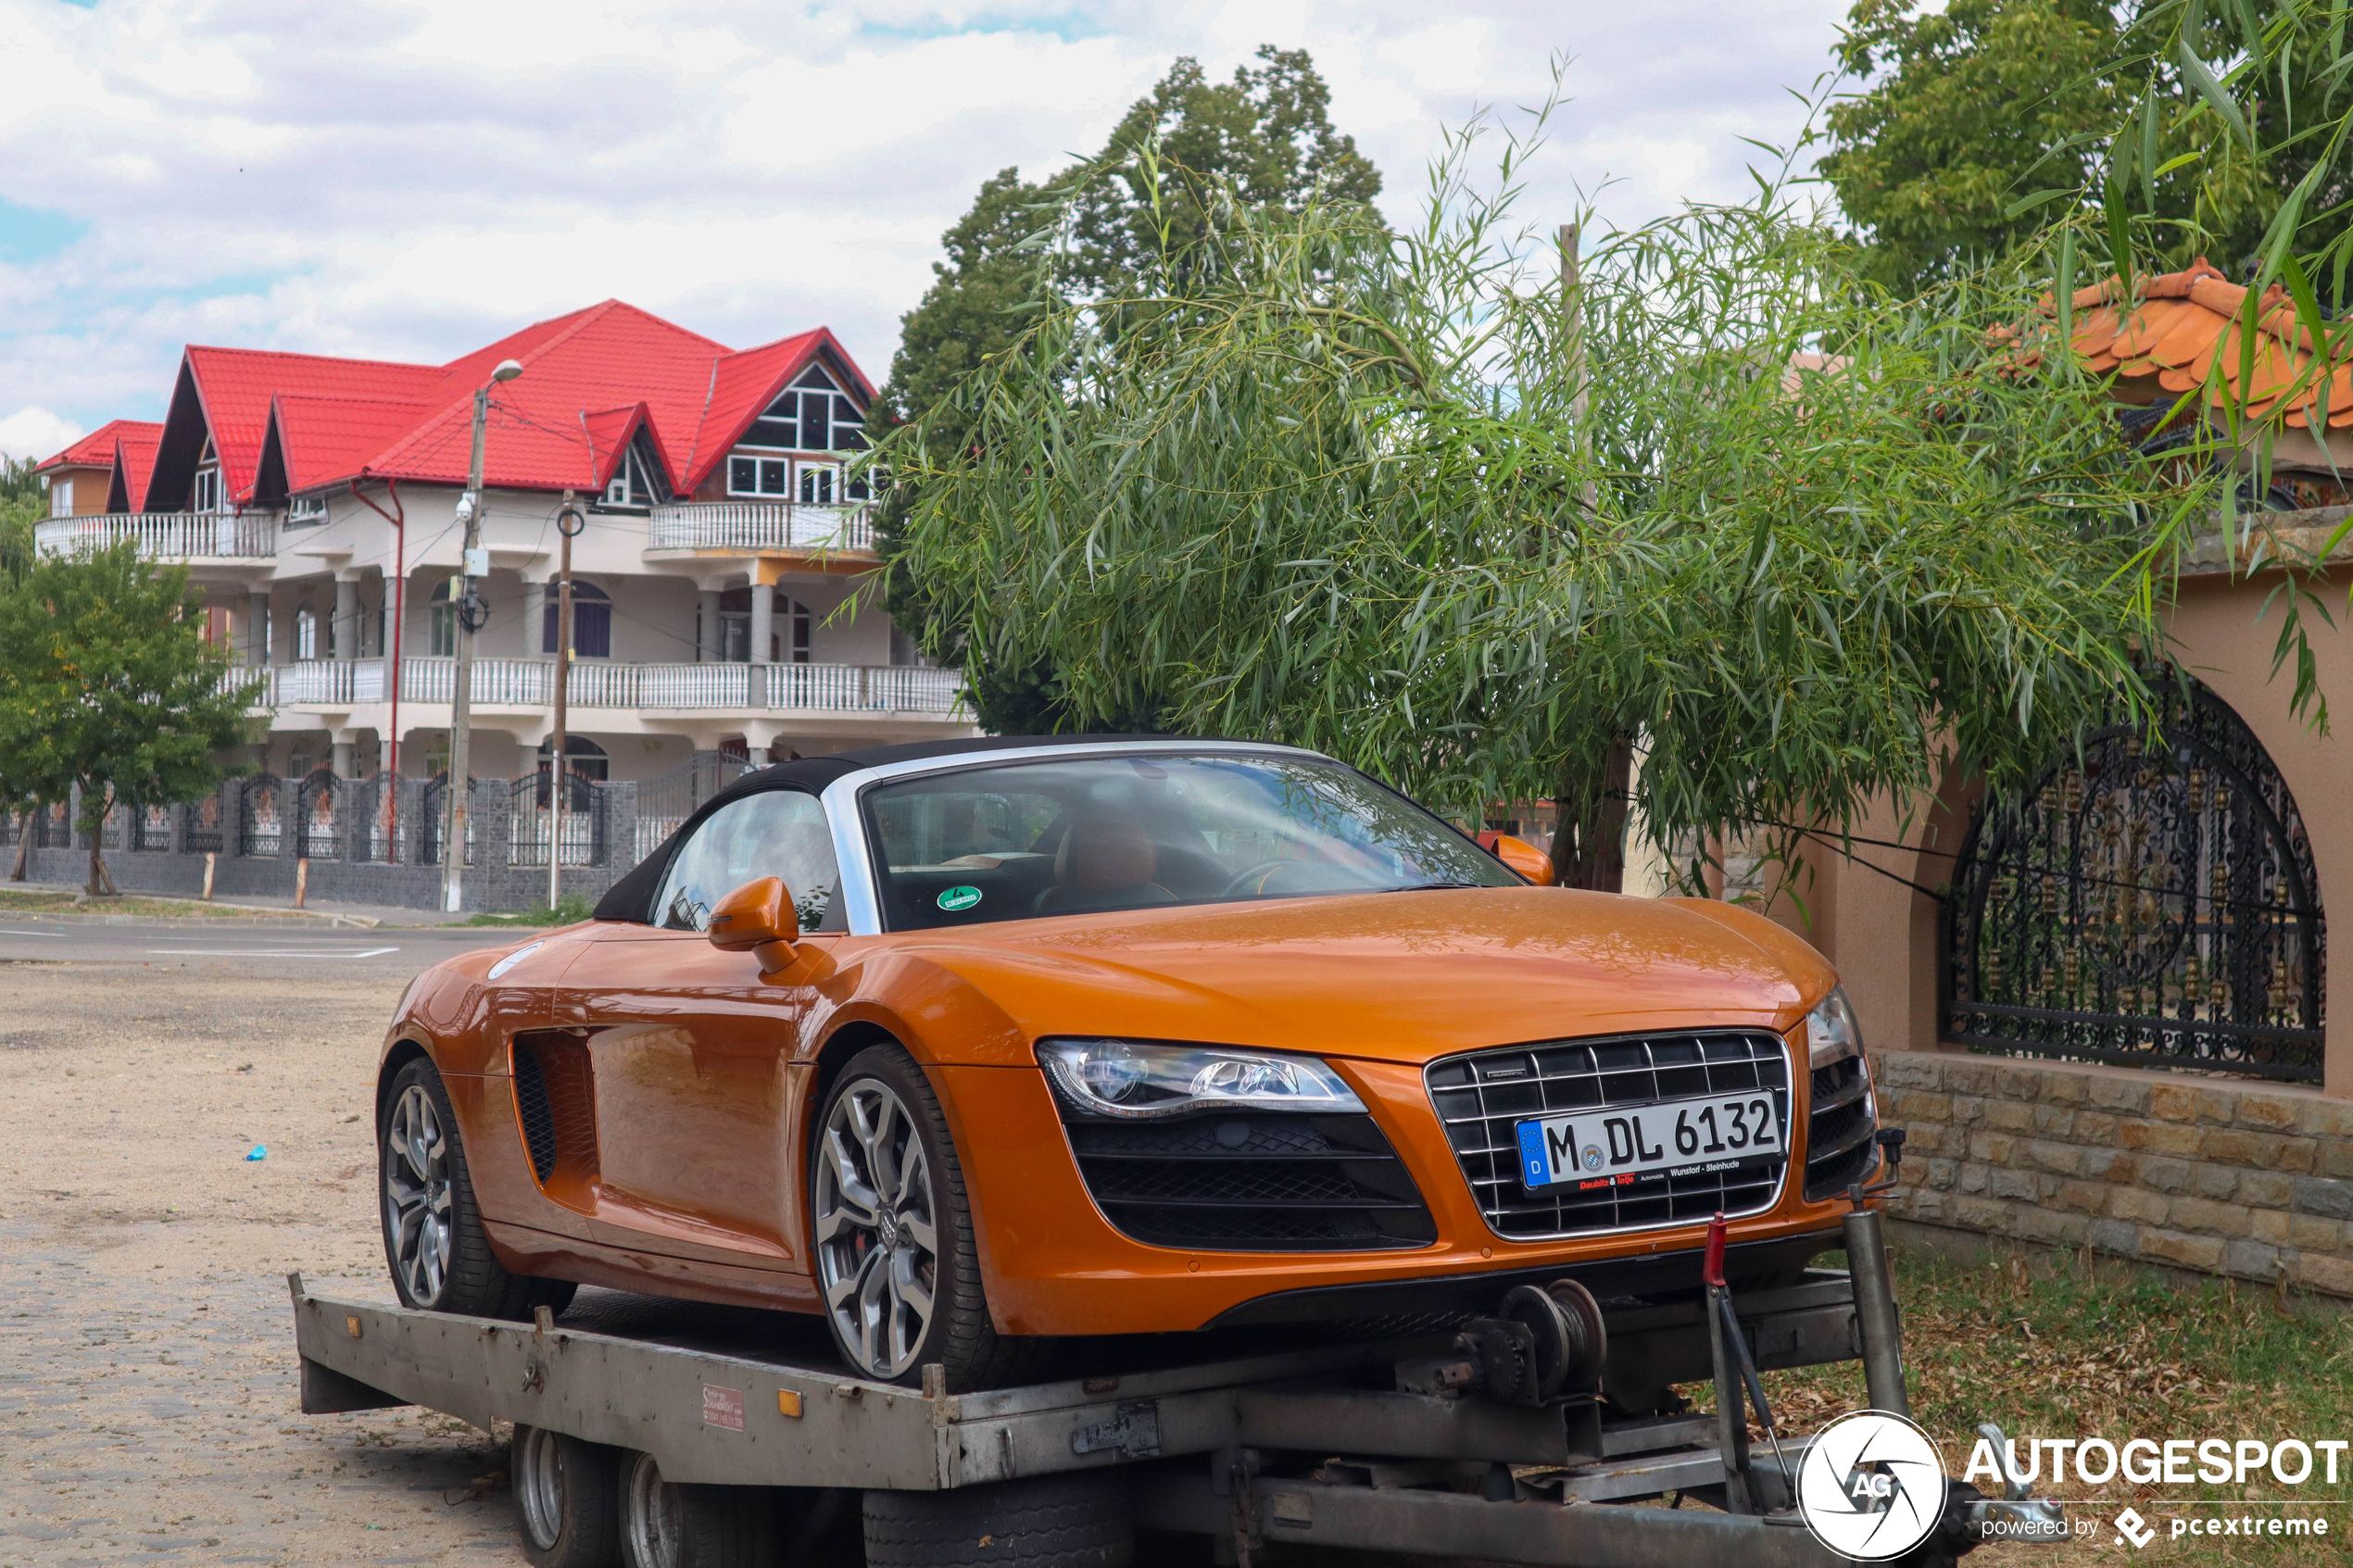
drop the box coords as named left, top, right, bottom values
left=0, top=938, right=522, bottom=1568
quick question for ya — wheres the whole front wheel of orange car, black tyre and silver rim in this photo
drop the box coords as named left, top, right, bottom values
left=810, top=1047, right=1051, bottom=1394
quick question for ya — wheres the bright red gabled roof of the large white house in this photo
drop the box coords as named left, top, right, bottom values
left=131, top=298, right=873, bottom=501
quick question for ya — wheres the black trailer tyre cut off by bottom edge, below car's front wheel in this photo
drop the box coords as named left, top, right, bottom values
left=866, top=1472, right=1137, bottom=1568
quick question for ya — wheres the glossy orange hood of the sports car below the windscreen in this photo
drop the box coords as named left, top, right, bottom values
left=883, top=888, right=1833, bottom=1062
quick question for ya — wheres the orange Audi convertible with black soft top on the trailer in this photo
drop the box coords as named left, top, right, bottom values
left=376, top=738, right=1880, bottom=1389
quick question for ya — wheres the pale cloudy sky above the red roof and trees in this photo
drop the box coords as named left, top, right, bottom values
left=0, top=0, right=1847, bottom=456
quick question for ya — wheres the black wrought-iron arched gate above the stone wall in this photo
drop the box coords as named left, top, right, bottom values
left=1939, top=677, right=2327, bottom=1082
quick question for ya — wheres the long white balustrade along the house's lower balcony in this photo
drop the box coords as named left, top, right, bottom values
left=231, top=659, right=964, bottom=715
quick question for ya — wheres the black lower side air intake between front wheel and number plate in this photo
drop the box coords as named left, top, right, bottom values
left=1056, top=1096, right=1438, bottom=1253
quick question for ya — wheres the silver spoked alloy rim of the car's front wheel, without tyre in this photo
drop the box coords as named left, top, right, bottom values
left=814, top=1079, right=938, bottom=1377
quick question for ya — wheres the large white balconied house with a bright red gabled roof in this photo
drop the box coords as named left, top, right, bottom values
left=35, top=301, right=972, bottom=798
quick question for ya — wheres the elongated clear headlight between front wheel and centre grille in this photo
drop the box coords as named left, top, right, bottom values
left=1038, top=1039, right=1365, bottom=1119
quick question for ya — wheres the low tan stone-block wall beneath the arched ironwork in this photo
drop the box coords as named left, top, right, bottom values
left=1870, top=1051, right=2353, bottom=1296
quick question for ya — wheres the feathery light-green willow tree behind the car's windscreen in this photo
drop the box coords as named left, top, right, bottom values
left=880, top=125, right=2182, bottom=886
